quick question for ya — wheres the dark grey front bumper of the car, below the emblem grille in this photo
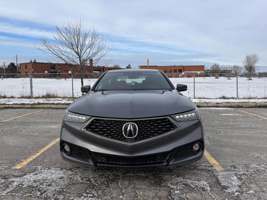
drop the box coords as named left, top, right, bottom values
left=60, top=117, right=204, bottom=167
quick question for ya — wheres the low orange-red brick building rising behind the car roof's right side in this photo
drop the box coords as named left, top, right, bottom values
left=139, top=65, right=205, bottom=77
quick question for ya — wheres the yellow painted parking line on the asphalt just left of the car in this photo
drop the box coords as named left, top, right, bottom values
left=13, top=138, right=59, bottom=169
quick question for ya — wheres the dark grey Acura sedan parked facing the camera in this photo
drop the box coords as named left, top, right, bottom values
left=60, top=69, right=204, bottom=167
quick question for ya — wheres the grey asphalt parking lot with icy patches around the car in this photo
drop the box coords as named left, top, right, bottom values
left=0, top=108, right=267, bottom=200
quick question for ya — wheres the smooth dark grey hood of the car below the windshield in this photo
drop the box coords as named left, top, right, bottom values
left=68, top=90, right=195, bottom=119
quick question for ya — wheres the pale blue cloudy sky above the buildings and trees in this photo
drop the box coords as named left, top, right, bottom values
left=0, top=0, right=267, bottom=66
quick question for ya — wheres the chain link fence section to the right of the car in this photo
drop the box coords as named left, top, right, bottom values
left=171, top=76, right=267, bottom=99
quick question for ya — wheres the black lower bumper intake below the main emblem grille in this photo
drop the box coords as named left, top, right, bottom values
left=92, top=153, right=168, bottom=166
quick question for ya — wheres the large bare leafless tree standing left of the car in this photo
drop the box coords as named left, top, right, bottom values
left=42, top=23, right=107, bottom=86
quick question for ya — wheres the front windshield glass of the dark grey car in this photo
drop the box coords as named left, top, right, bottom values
left=95, top=71, right=172, bottom=91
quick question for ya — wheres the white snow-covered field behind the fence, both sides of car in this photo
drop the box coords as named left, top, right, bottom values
left=0, top=77, right=267, bottom=98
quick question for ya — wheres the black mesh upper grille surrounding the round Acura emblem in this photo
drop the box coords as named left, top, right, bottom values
left=85, top=117, right=176, bottom=142
